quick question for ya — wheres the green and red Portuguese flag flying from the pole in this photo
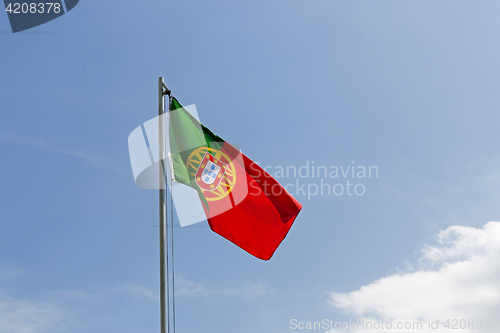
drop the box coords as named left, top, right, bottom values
left=168, top=98, right=302, bottom=260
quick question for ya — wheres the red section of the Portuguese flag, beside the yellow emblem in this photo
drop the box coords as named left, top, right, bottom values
left=204, top=143, right=302, bottom=260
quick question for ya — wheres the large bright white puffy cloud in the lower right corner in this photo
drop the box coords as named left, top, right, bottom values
left=330, top=222, right=500, bottom=332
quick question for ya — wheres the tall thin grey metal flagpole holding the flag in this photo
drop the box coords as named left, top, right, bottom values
left=158, top=77, right=170, bottom=333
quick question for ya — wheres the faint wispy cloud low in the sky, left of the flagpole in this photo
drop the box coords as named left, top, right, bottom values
left=0, top=260, right=158, bottom=333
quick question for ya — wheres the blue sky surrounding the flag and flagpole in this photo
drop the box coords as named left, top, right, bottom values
left=0, top=0, right=500, bottom=333
